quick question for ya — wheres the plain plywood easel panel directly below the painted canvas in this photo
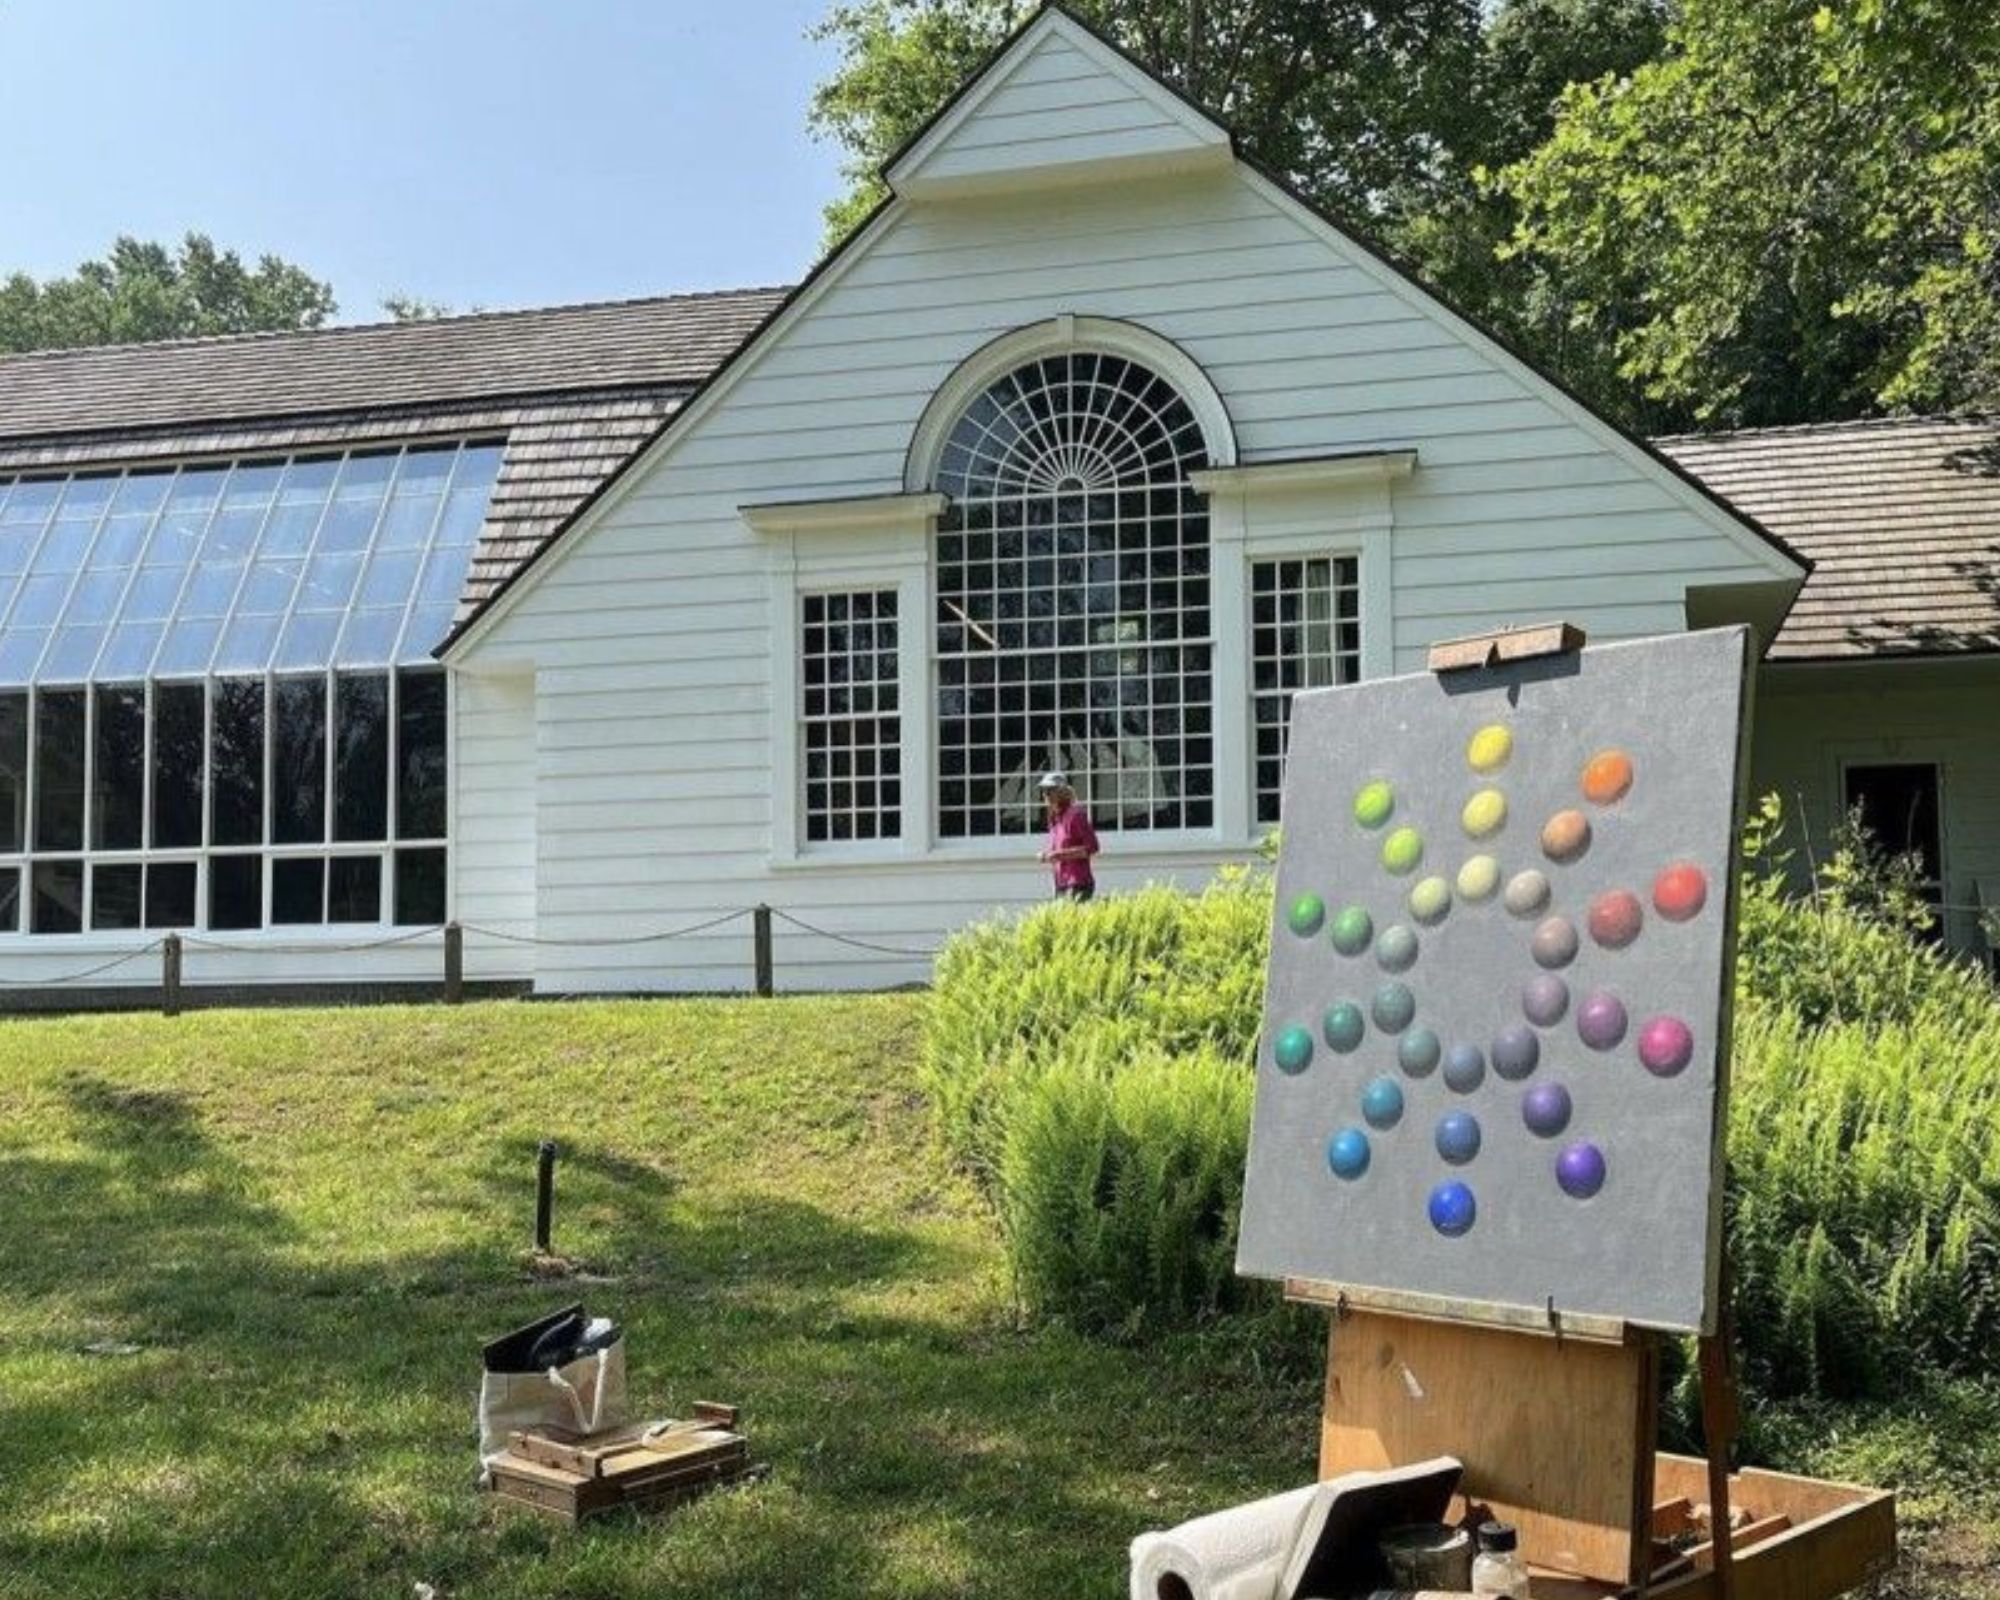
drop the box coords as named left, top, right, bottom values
left=1320, top=1312, right=1656, bottom=1584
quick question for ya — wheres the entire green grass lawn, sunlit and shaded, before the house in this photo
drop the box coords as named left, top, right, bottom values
left=0, top=996, right=2000, bottom=1600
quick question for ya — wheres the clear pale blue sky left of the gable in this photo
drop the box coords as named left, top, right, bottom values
left=0, top=0, right=840, bottom=322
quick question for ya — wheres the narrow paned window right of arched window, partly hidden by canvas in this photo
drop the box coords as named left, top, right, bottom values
left=1250, top=556, right=1362, bottom=822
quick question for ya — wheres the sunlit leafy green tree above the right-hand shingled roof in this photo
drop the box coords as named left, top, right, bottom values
left=1498, top=0, right=2000, bottom=426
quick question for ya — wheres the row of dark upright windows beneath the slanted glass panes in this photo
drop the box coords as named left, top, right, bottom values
left=0, top=668, right=448, bottom=934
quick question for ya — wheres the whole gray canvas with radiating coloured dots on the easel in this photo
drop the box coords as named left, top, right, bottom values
left=1238, top=628, right=1748, bottom=1332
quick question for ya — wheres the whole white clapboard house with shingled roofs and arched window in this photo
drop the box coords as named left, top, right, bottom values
left=0, top=10, right=2000, bottom=996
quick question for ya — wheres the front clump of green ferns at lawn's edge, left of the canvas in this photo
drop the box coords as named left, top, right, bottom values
left=1000, top=1050, right=1252, bottom=1336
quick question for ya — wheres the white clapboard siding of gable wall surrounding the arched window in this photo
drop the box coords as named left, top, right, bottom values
left=460, top=97, right=1772, bottom=992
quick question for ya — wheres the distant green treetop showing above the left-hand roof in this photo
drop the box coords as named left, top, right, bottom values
left=0, top=234, right=338, bottom=352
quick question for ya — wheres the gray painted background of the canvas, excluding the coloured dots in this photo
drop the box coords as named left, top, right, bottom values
left=1236, top=628, right=1748, bottom=1330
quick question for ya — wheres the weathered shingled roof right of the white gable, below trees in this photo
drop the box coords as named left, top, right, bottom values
left=1654, top=416, right=2000, bottom=662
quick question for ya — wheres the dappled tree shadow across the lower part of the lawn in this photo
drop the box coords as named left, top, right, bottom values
left=0, top=1078, right=1310, bottom=1596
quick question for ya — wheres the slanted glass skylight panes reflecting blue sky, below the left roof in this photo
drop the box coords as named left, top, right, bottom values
left=0, top=442, right=500, bottom=684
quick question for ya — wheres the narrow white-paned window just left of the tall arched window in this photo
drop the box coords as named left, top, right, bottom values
left=800, top=588, right=902, bottom=844
